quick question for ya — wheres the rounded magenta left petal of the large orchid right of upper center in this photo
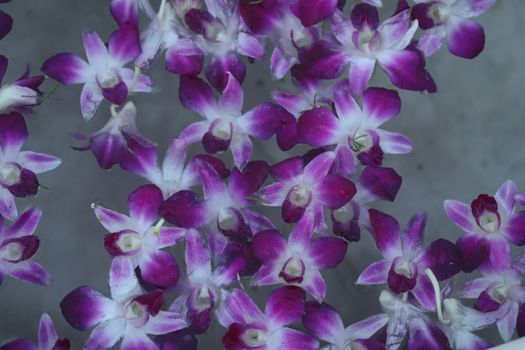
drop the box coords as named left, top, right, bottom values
left=297, top=108, right=339, bottom=147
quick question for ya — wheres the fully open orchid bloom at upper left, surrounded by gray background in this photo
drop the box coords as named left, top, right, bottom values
left=42, top=23, right=151, bottom=120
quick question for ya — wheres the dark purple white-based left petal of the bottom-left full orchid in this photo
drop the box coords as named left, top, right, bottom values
left=60, top=286, right=116, bottom=331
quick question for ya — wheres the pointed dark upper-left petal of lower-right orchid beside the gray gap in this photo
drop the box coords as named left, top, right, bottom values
left=368, top=209, right=401, bottom=259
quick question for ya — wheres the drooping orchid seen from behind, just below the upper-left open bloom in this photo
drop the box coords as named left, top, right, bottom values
left=73, top=101, right=155, bottom=169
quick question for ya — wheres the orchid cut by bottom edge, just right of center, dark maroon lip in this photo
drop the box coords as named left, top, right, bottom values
left=217, top=287, right=319, bottom=350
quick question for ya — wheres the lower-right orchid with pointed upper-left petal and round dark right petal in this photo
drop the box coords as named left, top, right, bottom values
left=356, top=209, right=462, bottom=310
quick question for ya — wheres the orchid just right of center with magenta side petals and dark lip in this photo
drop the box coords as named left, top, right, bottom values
left=260, top=152, right=356, bottom=232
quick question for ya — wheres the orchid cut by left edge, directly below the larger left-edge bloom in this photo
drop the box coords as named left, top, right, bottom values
left=0, top=207, right=51, bottom=285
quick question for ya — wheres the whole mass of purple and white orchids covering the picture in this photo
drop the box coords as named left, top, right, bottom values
left=0, top=0, right=525, bottom=350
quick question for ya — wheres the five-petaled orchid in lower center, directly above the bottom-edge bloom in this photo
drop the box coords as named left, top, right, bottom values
left=252, top=216, right=347, bottom=301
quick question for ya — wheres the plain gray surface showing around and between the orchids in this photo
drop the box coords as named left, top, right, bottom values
left=0, top=0, right=525, bottom=349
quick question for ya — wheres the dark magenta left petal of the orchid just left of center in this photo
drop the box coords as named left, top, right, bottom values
left=160, top=190, right=206, bottom=228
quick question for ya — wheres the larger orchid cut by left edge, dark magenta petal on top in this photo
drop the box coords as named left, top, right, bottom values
left=0, top=112, right=60, bottom=221
